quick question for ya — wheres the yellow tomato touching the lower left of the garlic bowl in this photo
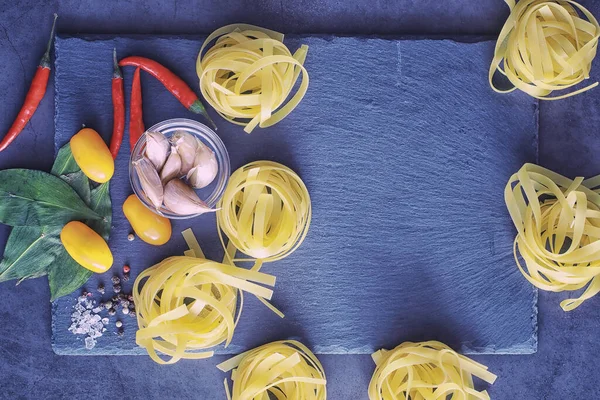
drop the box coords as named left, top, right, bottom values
left=123, top=194, right=171, bottom=246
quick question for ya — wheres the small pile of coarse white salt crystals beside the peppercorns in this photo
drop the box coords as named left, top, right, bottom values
left=69, top=296, right=108, bottom=350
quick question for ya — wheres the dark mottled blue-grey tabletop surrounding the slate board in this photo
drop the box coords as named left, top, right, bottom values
left=0, top=0, right=600, bottom=399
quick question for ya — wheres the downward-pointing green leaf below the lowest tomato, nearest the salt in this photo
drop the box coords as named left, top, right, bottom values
left=48, top=246, right=93, bottom=301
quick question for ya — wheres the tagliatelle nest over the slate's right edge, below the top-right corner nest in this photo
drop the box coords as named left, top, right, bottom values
left=504, top=164, right=600, bottom=311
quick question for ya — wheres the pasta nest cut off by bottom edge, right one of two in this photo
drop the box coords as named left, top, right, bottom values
left=369, top=341, right=496, bottom=400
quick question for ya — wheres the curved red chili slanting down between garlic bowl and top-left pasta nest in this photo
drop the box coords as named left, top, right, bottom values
left=119, top=56, right=217, bottom=130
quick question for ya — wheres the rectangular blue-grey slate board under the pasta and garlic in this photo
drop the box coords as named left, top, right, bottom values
left=52, top=33, right=537, bottom=355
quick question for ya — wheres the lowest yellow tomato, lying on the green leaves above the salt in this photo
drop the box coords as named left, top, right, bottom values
left=60, top=221, right=113, bottom=273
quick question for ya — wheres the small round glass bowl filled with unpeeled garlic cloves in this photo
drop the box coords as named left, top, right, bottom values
left=129, top=118, right=231, bottom=219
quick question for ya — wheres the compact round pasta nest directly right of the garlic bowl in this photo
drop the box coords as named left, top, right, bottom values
left=217, top=161, right=312, bottom=266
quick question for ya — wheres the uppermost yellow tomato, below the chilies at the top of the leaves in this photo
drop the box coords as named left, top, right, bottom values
left=70, top=128, right=115, bottom=183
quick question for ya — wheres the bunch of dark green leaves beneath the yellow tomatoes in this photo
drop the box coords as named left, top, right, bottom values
left=0, top=143, right=112, bottom=301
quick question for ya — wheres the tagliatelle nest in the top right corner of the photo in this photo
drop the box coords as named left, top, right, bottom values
left=489, top=0, right=600, bottom=100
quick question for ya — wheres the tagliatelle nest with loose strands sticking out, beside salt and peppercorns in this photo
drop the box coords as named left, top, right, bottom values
left=133, top=231, right=275, bottom=364
